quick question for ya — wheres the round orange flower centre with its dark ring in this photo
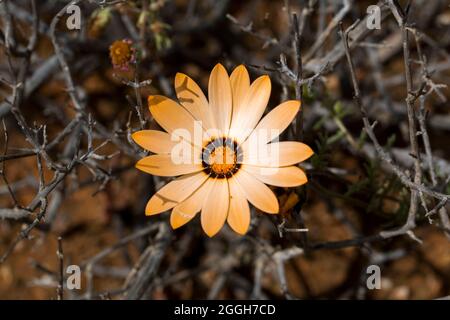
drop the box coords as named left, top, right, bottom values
left=202, top=138, right=242, bottom=178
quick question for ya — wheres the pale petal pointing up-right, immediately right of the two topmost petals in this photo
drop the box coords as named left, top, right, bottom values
left=230, top=75, right=271, bottom=142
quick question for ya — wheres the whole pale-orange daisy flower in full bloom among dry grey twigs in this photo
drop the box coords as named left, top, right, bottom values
left=132, top=64, right=313, bottom=237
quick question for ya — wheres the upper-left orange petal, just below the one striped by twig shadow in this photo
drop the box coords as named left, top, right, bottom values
left=148, top=95, right=203, bottom=147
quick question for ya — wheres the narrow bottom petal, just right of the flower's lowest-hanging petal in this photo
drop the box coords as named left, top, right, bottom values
left=227, top=180, right=250, bottom=234
